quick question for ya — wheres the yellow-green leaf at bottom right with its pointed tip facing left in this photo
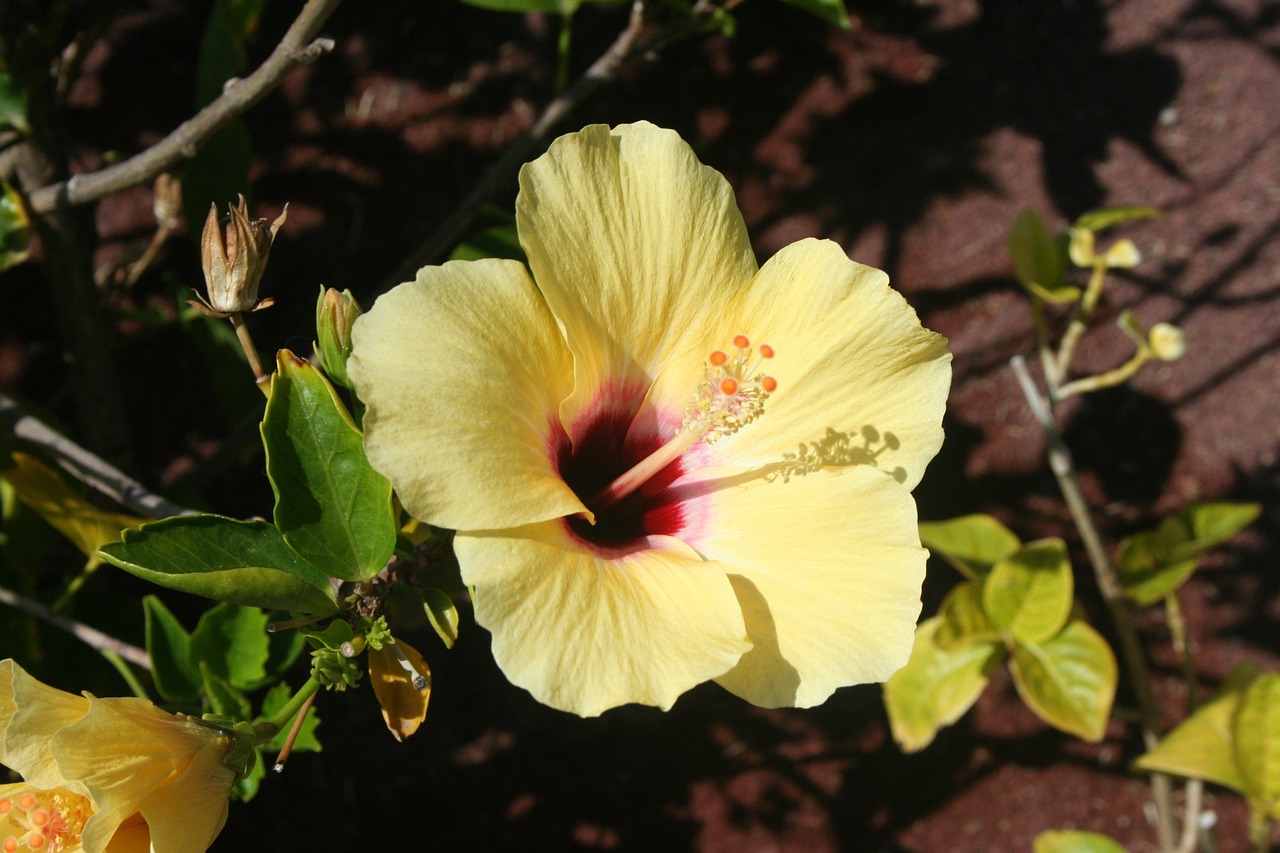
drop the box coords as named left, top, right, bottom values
left=1134, top=663, right=1258, bottom=793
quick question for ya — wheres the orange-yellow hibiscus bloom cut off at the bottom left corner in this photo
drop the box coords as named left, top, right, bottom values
left=0, top=660, right=237, bottom=853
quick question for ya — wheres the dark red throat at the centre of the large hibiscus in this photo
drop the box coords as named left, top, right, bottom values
left=557, top=414, right=685, bottom=548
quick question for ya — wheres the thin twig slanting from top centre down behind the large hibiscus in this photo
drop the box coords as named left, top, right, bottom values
left=383, top=0, right=737, bottom=285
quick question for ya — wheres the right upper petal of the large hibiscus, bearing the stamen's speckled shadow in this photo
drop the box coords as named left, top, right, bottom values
left=686, top=240, right=951, bottom=489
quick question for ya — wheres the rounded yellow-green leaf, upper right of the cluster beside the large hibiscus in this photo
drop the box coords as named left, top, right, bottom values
left=982, top=539, right=1073, bottom=643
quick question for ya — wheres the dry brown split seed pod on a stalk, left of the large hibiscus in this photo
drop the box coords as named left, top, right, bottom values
left=200, top=196, right=288, bottom=316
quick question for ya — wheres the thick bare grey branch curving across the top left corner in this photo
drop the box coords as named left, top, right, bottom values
left=28, top=0, right=342, bottom=215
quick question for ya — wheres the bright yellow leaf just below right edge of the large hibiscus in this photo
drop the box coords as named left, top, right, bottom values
left=884, top=616, right=1005, bottom=752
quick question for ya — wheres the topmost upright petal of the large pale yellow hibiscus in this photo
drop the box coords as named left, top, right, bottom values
left=516, top=122, right=756, bottom=434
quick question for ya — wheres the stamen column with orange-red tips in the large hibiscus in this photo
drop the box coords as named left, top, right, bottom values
left=586, top=334, right=778, bottom=512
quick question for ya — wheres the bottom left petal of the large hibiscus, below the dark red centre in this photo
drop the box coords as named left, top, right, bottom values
left=454, top=521, right=750, bottom=717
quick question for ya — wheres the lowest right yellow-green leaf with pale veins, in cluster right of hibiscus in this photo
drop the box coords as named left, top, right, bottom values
left=1009, top=620, right=1116, bottom=742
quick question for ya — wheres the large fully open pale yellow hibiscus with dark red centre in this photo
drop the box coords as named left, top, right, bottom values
left=348, top=123, right=951, bottom=716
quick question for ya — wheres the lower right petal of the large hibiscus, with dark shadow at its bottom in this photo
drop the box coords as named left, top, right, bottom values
left=672, top=466, right=928, bottom=707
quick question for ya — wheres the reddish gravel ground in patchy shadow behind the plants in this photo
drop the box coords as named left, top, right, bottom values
left=0, top=0, right=1280, bottom=853
